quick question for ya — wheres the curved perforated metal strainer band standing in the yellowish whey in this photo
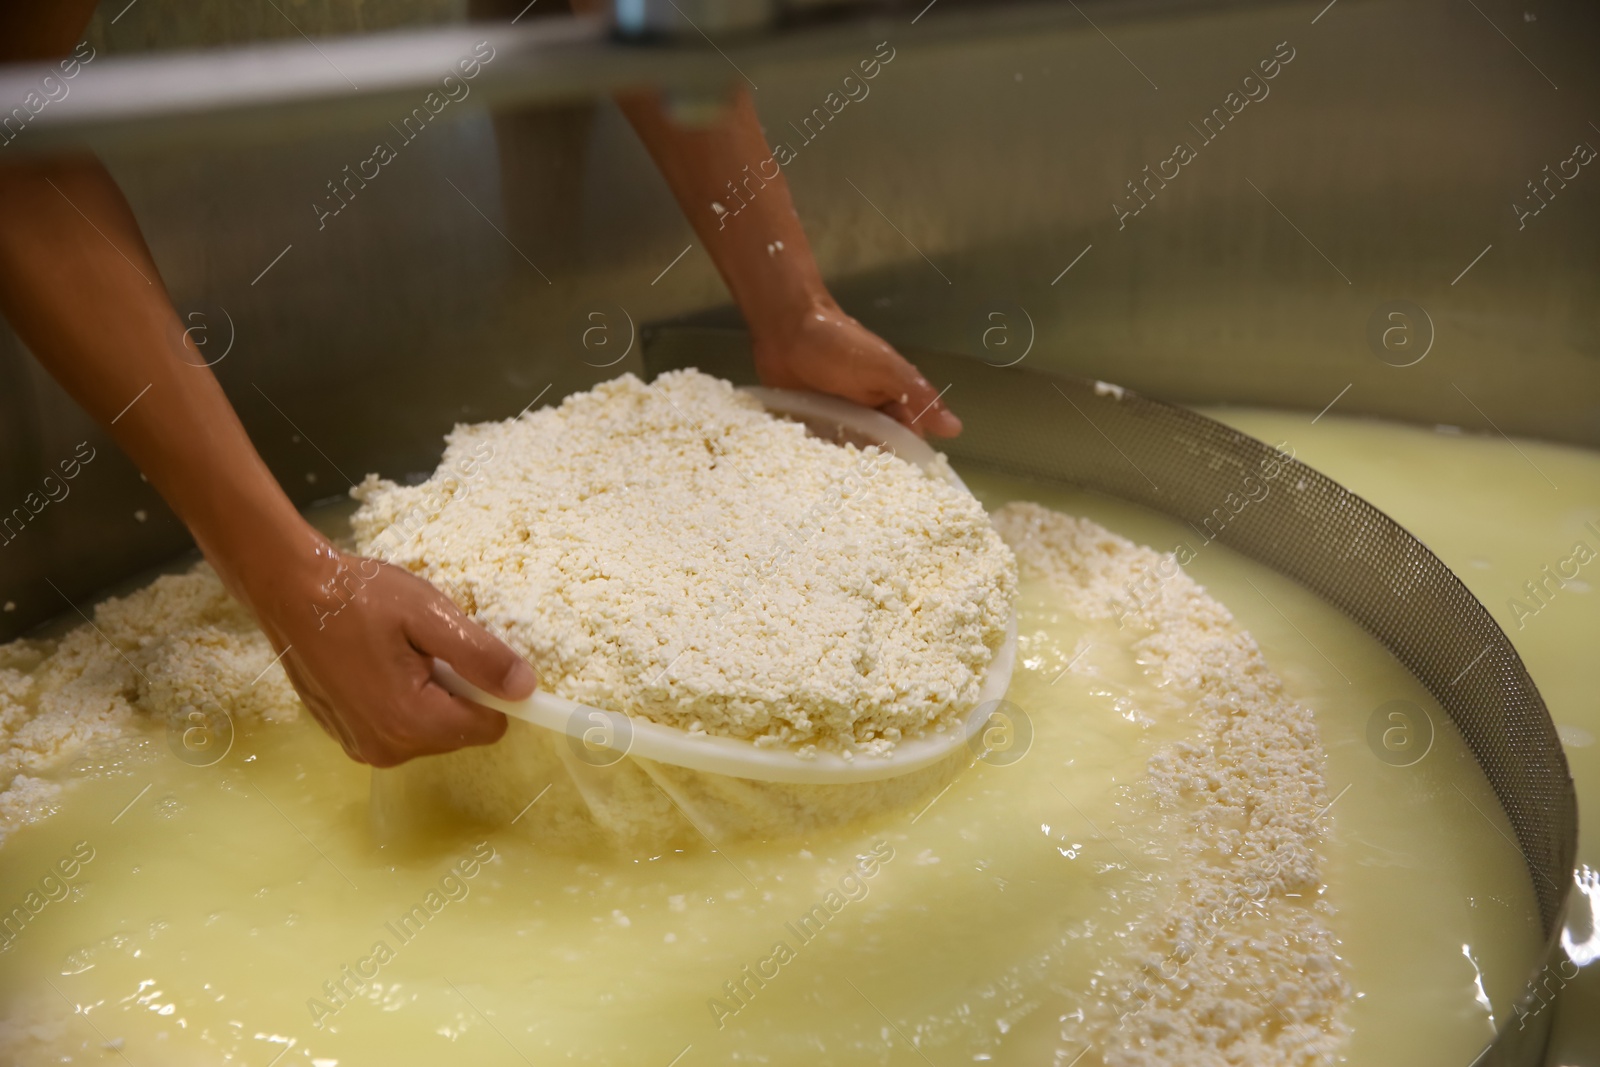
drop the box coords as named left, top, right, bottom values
left=645, top=328, right=1578, bottom=1067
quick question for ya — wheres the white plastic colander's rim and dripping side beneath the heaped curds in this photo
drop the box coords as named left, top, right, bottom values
left=373, top=389, right=1016, bottom=853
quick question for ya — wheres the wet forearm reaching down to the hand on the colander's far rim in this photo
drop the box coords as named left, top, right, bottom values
left=618, top=88, right=832, bottom=333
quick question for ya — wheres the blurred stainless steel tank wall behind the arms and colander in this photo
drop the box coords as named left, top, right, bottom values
left=0, top=0, right=1600, bottom=1062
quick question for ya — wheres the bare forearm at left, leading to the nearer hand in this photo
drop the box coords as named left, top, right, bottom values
left=0, top=157, right=320, bottom=593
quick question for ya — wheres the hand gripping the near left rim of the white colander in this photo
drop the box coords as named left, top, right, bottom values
left=245, top=541, right=538, bottom=766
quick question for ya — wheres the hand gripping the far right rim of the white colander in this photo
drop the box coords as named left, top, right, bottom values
left=752, top=299, right=962, bottom=437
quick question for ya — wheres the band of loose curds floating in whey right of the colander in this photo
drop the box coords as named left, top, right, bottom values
left=994, top=502, right=1350, bottom=1067
